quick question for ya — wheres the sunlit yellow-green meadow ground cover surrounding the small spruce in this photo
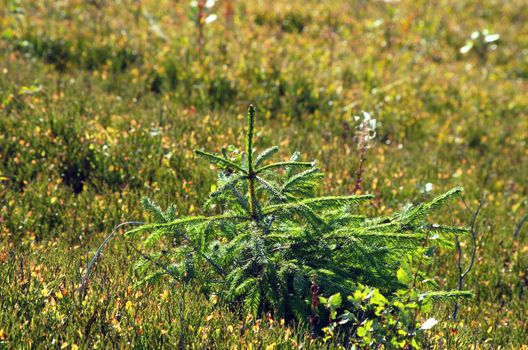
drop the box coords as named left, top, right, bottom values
left=0, top=0, right=528, bottom=349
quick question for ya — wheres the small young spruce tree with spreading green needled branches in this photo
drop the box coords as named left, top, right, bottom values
left=128, top=106, right=464, bottom=332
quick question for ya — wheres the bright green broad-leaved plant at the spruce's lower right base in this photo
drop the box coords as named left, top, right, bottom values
left=320, top=284, right=471, bottom=349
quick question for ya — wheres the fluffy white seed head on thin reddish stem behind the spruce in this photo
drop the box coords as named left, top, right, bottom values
left=353, top=111, right=378, bottom=193
